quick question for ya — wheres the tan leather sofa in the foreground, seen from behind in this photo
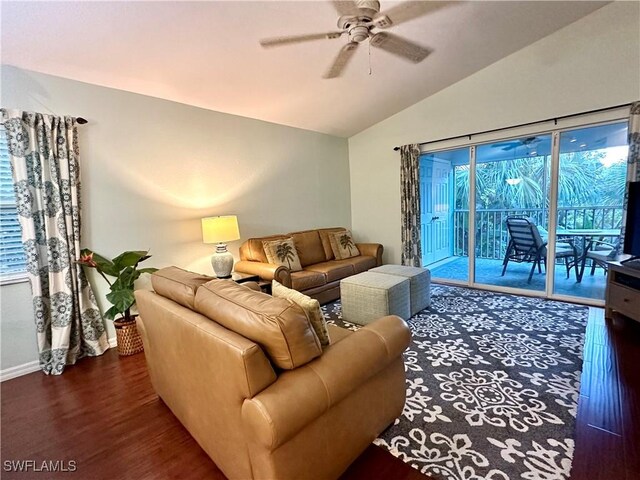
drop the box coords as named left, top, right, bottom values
left=136, top=267, right=410, bottom=480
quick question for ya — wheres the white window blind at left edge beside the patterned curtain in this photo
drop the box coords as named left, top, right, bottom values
left=0, top=126, right=27, bottom=277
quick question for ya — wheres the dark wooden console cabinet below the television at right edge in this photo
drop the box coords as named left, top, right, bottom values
left=604, top=262, right=640, bottom=322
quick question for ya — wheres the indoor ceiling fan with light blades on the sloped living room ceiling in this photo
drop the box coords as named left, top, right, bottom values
left=260, top=0, right=447, bottom=78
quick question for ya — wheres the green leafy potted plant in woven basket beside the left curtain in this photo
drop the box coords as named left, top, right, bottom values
left=78, top=248, right=158, bottom=355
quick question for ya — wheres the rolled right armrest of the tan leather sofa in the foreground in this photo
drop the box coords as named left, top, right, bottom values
left=242, top=315, right=411, bottom=450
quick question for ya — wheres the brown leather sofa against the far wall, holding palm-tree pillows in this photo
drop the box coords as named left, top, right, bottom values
left=234, top=227, right=383, bottom=303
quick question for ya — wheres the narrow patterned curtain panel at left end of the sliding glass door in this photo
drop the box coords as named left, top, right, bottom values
left=400, top=145, right=422, bottom=267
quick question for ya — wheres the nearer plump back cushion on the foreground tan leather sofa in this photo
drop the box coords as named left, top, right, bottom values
left=195, top=280, right=322, bottom=370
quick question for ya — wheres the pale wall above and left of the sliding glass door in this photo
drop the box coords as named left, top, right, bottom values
left=349, top=2, right=640, bottom=263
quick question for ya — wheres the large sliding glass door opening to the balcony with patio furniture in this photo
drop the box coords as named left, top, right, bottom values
left=420, top=121, right=627, bottom=301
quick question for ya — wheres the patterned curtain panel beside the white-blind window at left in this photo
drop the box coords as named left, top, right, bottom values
left=1, top=109, right=109, bottom=375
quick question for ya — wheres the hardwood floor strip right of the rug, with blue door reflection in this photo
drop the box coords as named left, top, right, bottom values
left=571, top=305, right=640, bottom=480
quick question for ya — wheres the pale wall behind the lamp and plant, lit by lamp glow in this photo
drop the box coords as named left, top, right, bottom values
left=0, top=66, right=351, bottom=369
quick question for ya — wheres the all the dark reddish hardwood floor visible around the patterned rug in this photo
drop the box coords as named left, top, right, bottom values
left=0, top=308, right=640, bottom=480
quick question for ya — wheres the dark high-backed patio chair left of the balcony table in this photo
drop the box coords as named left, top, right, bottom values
left=502, top=216, right=579, bottom=283
